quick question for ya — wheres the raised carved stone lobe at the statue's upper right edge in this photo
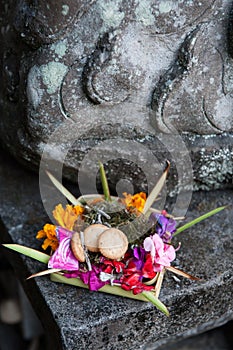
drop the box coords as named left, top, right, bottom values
left=153, top=18, right=233, bottom=134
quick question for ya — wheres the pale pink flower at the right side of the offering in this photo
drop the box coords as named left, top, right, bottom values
left=143, top=233, right=176, bottom=272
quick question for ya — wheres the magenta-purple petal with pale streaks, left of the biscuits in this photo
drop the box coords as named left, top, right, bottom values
left=48, top=227, right=79, bottom=271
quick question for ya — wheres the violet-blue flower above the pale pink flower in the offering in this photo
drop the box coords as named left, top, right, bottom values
left=149, top=213, right=176, bottom=242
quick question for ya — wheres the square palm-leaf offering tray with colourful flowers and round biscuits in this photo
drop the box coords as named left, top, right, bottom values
left=4, top=162, right=225, bottom=316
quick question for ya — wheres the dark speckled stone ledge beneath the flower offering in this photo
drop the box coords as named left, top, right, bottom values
left=0, top=149, right=233, bottom=350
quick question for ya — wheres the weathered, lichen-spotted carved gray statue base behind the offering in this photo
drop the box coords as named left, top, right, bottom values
left=0, top=0, right=233, bottom=189
